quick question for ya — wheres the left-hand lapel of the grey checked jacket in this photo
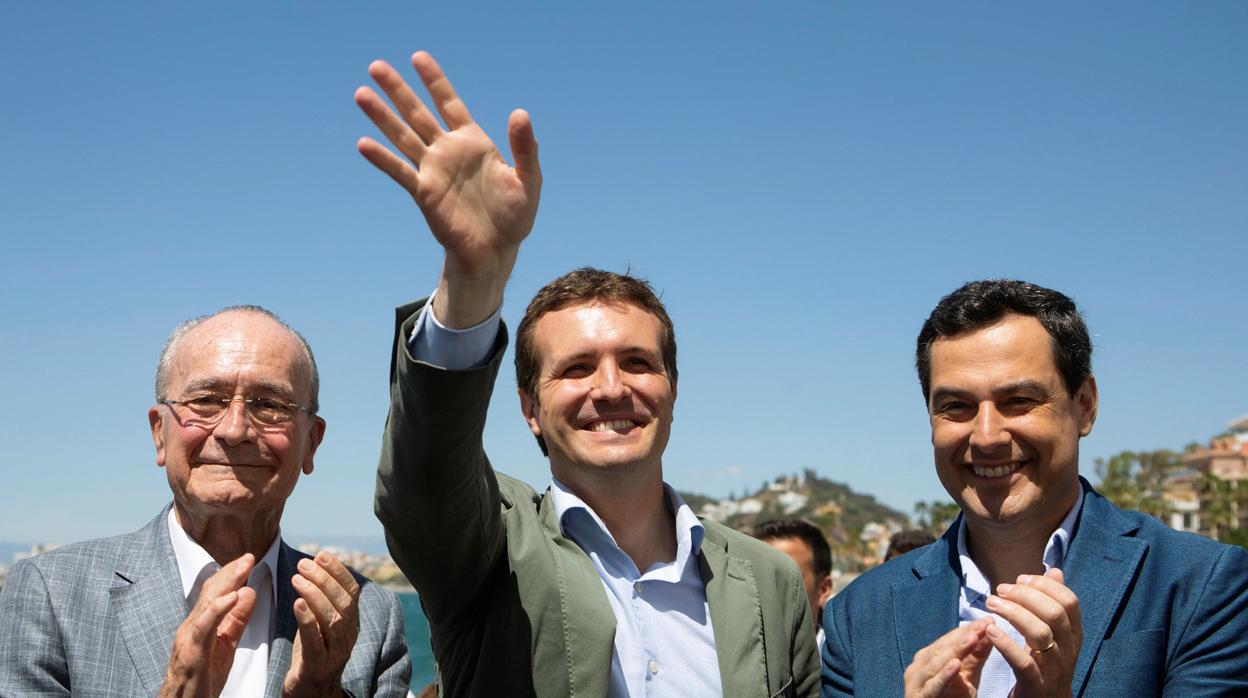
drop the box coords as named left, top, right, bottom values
left=109, top=507, right=188, bottom=696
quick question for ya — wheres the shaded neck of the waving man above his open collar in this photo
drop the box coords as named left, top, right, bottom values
left=554, top=469, right=676, bottom=572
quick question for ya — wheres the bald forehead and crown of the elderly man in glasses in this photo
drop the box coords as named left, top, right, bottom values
left=170, top=312, right=310, bottom=398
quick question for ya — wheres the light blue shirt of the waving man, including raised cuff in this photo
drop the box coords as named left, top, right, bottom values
left=408, top=296, right=723, bottom=698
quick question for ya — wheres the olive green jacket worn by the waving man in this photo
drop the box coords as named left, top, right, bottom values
left=376, top=302, right=819, bottom=697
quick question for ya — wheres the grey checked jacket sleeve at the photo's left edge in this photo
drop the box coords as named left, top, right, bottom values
left=0, top=559, right=70, bottom=697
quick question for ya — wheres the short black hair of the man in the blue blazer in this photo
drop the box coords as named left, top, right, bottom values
left=915, top=278, right=1092, bottom=400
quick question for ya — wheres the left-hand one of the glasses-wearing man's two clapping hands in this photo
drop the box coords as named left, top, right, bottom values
left=160, top=553, right=256, bottom=698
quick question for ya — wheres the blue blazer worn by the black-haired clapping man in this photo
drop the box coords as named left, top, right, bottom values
left=822, top=478, right=1248, bottom=698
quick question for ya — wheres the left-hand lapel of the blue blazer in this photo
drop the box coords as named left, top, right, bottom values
left=892, top=529, right=962, bottom=672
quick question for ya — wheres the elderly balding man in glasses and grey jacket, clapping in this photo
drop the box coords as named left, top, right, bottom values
left=0, top=306, right=411, bottom=697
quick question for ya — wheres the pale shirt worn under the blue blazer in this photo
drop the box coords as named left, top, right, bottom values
left=957, top=492, right=1083, bottom=698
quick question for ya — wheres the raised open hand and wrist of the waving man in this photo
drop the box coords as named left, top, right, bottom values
left=356, top=51, right=542, bottom=327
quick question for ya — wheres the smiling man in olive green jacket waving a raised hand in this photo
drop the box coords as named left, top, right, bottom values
left=356, top=52, right=819, bottom=696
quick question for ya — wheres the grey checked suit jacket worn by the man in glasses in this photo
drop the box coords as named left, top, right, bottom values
left=0, top=507, right=412, bottom=698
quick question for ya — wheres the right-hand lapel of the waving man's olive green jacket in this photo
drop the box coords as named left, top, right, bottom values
left=698, top=527, right=770, bottom=696
